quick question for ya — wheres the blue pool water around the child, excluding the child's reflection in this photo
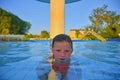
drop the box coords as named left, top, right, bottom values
left=0, top=40, right=120, bottom=80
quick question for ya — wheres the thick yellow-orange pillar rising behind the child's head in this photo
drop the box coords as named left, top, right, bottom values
left=50, top=0, right=65, bottom=39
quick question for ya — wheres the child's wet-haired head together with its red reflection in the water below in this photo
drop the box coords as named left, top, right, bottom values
left=52, top=34, right=73, bottom=79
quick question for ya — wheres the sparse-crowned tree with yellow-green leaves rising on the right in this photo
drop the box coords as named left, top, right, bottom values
left=89, top=5, right=120, bottom=38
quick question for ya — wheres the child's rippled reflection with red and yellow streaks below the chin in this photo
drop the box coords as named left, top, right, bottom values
left=37, top=56, right=81, bottom=80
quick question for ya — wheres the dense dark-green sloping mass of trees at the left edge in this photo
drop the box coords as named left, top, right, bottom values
left=0, top=8, right=31, bottom=34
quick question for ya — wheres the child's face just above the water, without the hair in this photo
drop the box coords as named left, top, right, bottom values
left=52, top=41, right=72, bottom=61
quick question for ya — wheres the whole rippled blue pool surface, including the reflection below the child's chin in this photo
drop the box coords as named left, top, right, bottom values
left=0, top=41, right=120, bottom=80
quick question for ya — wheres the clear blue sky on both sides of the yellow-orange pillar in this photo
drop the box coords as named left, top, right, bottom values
left=0, top=0, right=120, bottom=34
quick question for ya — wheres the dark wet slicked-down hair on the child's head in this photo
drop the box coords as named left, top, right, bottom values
left=52, top=34, right=73, bottom=50
